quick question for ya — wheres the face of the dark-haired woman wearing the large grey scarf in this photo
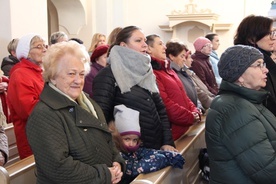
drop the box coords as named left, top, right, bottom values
left=120, top=30, right=148, bottom=54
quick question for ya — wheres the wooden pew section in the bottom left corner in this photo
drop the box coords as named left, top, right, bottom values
left=0, top=155, right=36, bottom=184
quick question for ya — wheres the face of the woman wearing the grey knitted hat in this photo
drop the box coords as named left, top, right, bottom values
left=238, top=59, right=268, bottom=90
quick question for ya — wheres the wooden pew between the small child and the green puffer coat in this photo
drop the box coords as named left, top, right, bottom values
left=131, top=117, right=206, bottom=184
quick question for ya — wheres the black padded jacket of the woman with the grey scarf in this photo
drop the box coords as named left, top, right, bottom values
left=92, top=66, right=174, bottom=149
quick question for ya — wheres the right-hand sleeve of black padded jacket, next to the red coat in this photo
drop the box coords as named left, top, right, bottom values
left=152, top=93, right=175, bottom=147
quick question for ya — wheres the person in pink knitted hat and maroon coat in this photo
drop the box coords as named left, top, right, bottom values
left=191, top=37, right=218, bottom=95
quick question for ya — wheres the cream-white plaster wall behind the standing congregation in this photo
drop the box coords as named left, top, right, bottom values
left=0, top=0, right=272, bottom=61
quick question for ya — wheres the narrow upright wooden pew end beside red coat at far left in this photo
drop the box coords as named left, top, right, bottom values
left=4, top=123, right=20, bottom=167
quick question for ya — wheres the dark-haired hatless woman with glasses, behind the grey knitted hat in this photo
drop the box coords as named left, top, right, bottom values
left=234, top=15, right=276, bottom=116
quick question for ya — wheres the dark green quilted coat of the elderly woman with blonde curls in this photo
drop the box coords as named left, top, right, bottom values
left=27, top=84, right=124, bottom=184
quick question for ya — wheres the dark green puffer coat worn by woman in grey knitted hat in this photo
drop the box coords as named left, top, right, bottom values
left=206, top=81, right=276, bottom=184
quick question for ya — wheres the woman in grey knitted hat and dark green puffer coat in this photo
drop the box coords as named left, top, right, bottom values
left=205, top=45, right=276, bottom=184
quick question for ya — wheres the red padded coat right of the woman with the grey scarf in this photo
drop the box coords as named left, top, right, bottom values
left=151, top=57, right=199, bottom=140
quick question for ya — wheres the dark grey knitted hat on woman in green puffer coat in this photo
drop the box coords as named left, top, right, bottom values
left=218, top=45, right=264, bottom=82
